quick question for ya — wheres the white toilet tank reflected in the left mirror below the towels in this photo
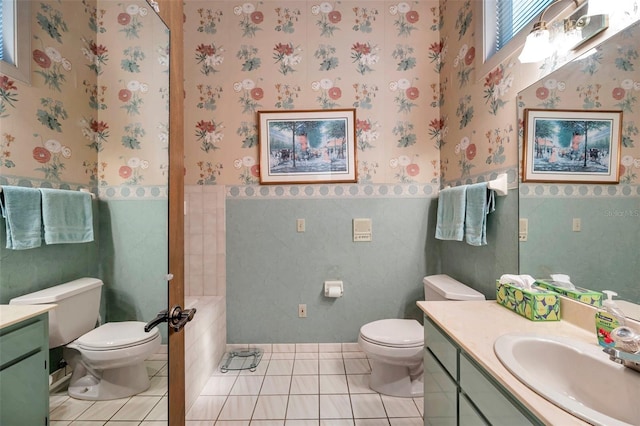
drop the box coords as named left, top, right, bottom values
left=9, top=278, right=102, bottom=348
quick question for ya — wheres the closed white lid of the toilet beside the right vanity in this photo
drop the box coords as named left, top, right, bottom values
left=360, top=319, right=424, bottom=348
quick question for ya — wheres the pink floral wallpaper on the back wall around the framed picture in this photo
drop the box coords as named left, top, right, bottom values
left=185, top=0, right=446, bottom=185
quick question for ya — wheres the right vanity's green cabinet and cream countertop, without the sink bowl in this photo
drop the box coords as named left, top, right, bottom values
left=418, top=301, right=597, bottom=426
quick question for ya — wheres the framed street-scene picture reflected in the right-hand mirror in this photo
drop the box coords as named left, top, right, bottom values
left=522, top=109, right=622, bottom=183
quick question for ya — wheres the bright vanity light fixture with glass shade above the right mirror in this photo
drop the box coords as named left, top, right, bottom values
left=518, top=0, right=609, bottom=63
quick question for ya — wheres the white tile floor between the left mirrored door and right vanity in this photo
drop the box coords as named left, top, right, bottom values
left=186, top=344, right=423, bottom=426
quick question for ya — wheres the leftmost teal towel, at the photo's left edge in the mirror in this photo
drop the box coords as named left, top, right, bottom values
left=0, top=186, right=42, bottom=250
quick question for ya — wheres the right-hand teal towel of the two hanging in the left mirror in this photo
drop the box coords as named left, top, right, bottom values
left=40, top=188, right=93, bottom=244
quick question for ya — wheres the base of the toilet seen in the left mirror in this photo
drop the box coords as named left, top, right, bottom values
left=68, top=362, right=150, bottom=401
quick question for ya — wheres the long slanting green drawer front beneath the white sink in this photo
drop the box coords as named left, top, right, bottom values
left=460, top=352, right=540, bottom=426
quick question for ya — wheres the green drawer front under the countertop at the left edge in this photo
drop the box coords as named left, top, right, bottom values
left=0, top=319, right=47, bottom=369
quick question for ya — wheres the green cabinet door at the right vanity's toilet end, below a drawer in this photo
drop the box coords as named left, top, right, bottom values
left=424, top=349, right=458, bottom=426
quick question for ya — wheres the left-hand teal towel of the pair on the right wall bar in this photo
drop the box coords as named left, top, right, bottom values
left=436, top=185, right=467, bottom=241
